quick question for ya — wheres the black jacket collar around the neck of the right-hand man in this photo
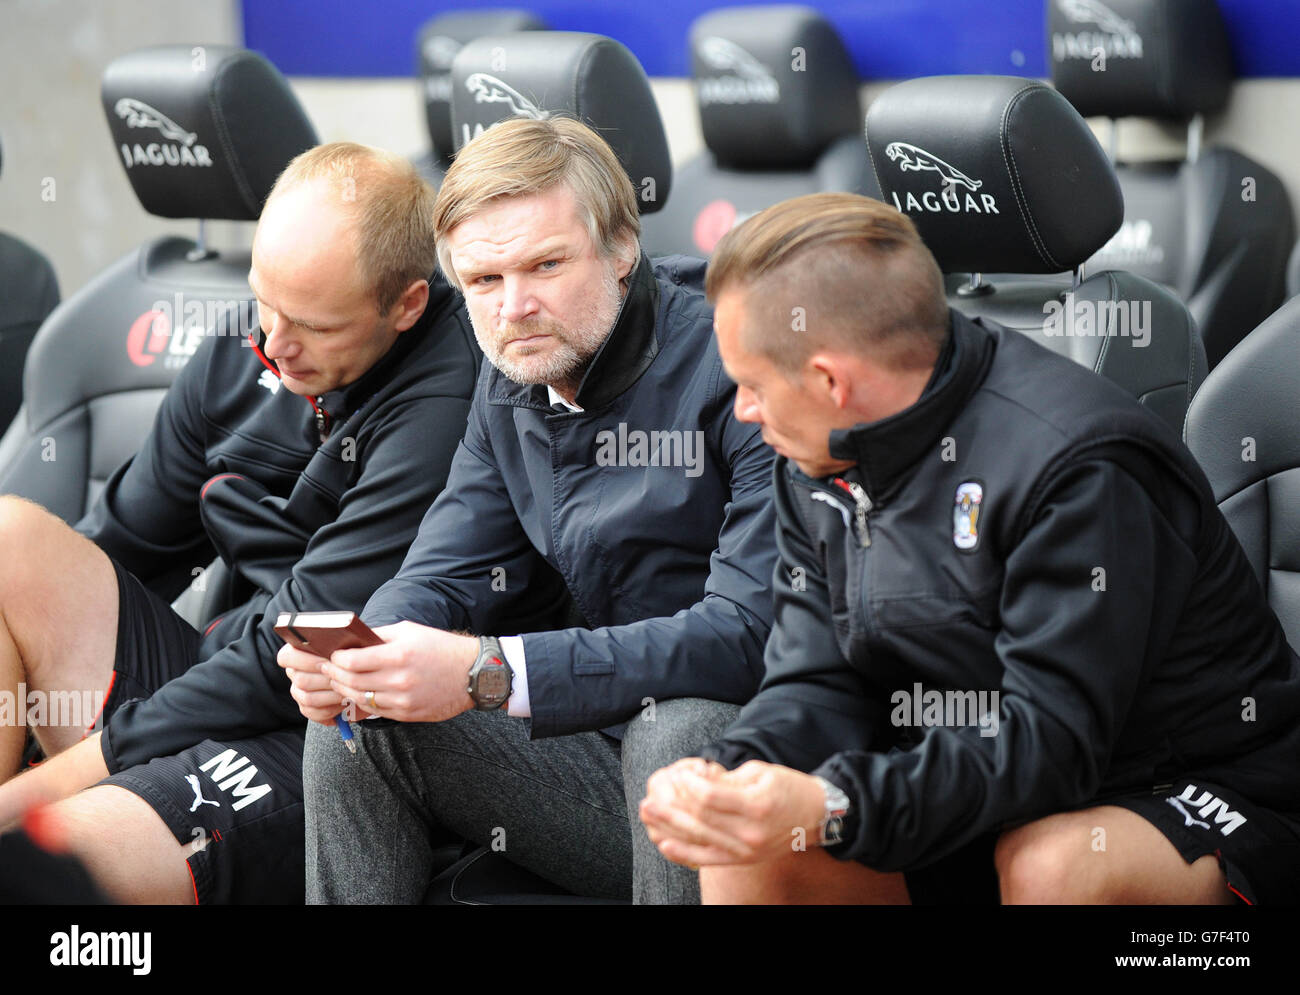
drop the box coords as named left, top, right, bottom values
left=831, top=308, right=995, bottom=501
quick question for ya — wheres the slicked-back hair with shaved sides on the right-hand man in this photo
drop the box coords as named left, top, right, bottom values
left=705, top=192, right=949, bottom=373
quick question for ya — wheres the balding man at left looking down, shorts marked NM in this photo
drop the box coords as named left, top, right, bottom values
left=0, top=143, right=481, bottom=904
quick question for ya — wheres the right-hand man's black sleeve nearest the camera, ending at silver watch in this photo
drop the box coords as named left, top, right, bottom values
left=816, top=459, right=1196, bottom=871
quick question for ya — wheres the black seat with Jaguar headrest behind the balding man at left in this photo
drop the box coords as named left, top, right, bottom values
left=0, top=44, right=316, bottom=543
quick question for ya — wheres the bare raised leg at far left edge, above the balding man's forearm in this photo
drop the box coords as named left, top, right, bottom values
left=0, top=496, right=118, bottom=783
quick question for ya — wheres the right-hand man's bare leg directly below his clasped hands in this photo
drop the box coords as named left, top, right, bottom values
left=699, top=849, right=910, bottom=905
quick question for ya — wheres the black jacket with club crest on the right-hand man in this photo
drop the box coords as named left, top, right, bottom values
left=706, top=312, right=1300, bottom=870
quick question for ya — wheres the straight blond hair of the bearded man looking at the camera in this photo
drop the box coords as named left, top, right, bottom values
left=433, top=116, right=641, bottom=289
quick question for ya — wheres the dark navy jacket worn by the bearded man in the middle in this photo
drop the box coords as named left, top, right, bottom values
left=364, top=256, right=776, bottom=737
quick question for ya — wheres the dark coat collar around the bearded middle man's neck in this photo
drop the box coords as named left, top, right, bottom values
left=489, top=252, right=659, bottom=411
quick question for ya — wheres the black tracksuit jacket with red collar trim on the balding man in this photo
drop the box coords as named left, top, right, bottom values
left=77, top=277, right=481, bottom=773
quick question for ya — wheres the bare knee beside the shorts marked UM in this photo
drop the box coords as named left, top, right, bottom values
left=993, top=805, right=1235, bottom=905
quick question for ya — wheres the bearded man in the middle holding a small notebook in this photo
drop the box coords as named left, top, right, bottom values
left=281, top=118, right=775, bottom=903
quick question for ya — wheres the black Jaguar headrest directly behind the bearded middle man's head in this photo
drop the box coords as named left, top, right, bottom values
left=451, top=31, right=672, bottom=215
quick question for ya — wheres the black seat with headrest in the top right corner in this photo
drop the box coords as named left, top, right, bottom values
left=1048, top=0, right=1295, bottom=368
